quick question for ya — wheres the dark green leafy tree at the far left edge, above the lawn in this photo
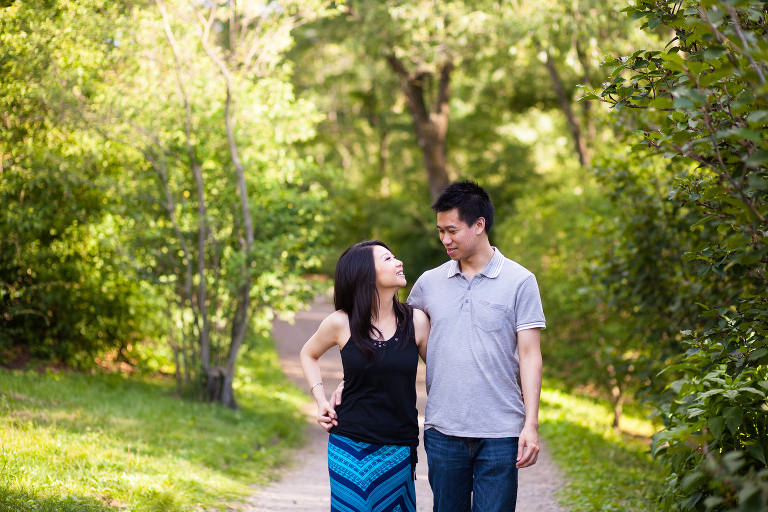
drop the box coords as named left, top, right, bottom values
left=0, top=2, right=158, bottom=367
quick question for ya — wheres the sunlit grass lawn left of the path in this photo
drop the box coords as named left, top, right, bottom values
left=0, top=338, right=305, bottom=512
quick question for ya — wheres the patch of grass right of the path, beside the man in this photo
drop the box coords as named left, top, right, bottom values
left=539, top=378, right=665, bottom=512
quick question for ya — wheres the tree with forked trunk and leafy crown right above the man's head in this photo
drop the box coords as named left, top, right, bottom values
left=296, top=1, right=524, bottom=199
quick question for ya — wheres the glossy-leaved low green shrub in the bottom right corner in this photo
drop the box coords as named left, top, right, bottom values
left=653, top=297, right=768, bottom=510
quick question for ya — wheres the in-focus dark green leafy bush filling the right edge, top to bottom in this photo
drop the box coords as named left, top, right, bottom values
left=585, top=0, right=768, bottom=511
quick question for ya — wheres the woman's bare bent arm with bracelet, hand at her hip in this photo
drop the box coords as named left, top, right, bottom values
left=299, top=311, right=349, bottom=430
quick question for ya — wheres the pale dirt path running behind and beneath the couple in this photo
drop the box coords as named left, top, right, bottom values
left=248, top=301, right=564, bottom=512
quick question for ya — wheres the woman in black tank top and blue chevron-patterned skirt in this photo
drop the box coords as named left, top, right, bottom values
left=301, top=240, right=429, bottom=512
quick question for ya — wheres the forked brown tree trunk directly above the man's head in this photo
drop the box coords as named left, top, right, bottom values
left=387, top=54, right=453, bottom=199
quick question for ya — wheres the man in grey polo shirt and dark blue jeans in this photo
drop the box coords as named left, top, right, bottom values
left=326, top=181, right=545, bottom=512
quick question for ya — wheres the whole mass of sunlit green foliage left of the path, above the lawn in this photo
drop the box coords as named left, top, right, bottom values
left=0, top=0, right=333, bottom=405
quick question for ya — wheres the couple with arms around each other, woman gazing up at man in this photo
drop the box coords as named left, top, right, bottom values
left=301, top=181, right=545, bottom=512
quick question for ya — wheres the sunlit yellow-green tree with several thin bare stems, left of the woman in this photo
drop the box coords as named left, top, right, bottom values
left=0, top=0, right=333, bottom=407
